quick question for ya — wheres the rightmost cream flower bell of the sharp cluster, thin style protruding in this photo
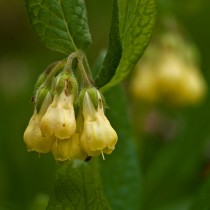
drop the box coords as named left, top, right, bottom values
left=80, top=90, right=118, bottom=156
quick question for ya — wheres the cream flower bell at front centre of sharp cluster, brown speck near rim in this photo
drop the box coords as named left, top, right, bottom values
left=41, top=91, right=76, bottom=139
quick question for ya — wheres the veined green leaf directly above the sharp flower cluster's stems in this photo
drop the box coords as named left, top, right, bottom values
left=25, top=0, right=91, bottom=55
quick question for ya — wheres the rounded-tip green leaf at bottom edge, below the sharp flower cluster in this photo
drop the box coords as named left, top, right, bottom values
left=47, top=160, right=110, bottom=210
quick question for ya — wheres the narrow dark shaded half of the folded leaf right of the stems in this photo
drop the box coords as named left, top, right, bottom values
left=95, top=0, right=122, bottom=88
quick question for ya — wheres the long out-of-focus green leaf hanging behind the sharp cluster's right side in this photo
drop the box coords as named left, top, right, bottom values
left=100, top=86, right=142, bottom=210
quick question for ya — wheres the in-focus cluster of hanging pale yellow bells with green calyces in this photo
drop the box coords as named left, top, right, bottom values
left=24, top=54, right=118, bottom=161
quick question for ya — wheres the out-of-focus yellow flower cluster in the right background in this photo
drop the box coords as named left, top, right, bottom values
left=130, top=31, right=207, bottom=105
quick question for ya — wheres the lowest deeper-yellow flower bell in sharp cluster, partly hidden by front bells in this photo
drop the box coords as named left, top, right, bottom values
left=52, top=133, right=87, bottom=161
